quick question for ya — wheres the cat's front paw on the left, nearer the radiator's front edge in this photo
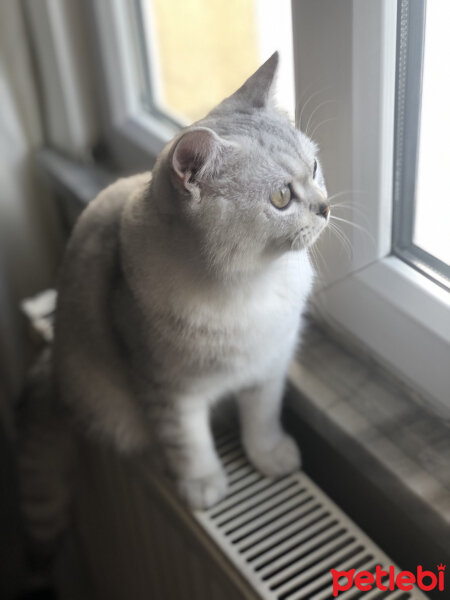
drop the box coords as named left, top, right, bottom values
left=177, top=471, right=228, bottom=509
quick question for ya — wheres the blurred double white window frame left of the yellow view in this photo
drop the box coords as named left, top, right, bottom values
left=24, top=0, right=178, bottom=172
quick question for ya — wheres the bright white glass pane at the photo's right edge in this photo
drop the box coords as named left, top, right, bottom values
left=393, top=0, right=450, bottom=289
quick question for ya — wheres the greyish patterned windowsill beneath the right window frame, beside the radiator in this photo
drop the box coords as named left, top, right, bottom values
left=287, top=322, right=450, bottom=560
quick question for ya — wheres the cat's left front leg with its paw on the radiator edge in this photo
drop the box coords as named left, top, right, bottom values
left=158, top=398, right=227, bottom=508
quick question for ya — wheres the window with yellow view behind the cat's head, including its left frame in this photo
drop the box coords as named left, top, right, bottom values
left=87, top=0, right=294, bottom=171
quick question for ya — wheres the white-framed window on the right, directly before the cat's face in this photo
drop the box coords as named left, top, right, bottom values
left=293, top=0, right=450, bottom=409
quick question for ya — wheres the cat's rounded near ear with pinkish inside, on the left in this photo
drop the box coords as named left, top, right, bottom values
left=171, top=127, right=230, bottom=191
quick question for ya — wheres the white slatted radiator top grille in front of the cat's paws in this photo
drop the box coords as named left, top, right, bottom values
left=195, top=433, right=426, bottom=600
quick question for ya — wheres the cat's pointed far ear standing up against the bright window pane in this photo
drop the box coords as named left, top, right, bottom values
left=212, top=52, right=279, bottom=113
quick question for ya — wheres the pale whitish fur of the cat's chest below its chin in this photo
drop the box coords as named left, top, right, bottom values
left=151, top=256, right=310, bottom=360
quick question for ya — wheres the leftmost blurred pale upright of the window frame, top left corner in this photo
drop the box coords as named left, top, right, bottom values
left=23, top=0, right=100, bottom=161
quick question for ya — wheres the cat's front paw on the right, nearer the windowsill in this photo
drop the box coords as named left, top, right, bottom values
left=247, top=433, right=301, bottom=477
